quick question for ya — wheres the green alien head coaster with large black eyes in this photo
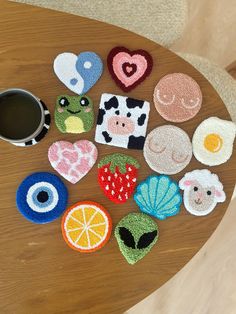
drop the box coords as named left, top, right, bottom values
left=115, top=213, right=159, bottom=265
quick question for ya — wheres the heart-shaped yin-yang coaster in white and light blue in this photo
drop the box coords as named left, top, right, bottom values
left=53, top=51, right=103, bottom=95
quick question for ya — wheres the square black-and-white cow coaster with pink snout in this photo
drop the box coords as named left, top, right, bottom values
left=95, top=94, right=150, bottom=149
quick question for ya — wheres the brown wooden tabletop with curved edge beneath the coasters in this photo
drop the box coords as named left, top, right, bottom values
left=0, top=1, right=236, bottom=314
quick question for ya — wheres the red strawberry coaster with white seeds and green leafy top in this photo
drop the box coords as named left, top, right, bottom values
left=98, top=154, right=140, bottom=203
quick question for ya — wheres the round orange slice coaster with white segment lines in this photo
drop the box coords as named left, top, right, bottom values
left=61, top=201, right=112, bottom=253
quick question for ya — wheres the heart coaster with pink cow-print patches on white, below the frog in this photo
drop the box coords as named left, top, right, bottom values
left=48, top=140, right=98, bottom=184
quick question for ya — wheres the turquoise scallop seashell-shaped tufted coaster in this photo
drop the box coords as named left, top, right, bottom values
left=134, top=175, right=182, bottom=220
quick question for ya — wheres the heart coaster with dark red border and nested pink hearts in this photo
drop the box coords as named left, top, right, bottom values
left=107, top=47, right=153, bottom=92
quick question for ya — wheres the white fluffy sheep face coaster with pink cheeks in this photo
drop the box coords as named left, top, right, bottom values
left=179, top=169, right=226, bottom=216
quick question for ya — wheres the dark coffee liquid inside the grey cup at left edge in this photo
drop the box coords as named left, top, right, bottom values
left=0, top=91, right=42, bottom=140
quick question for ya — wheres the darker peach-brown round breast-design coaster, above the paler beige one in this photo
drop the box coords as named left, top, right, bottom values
left=153, top=73, right=202, bottom=122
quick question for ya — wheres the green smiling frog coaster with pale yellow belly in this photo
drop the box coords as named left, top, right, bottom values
left=55, top=95, right=94, bottom=134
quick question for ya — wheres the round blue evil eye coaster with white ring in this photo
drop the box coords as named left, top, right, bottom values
left=16, top=172, right=68, bottom=224
